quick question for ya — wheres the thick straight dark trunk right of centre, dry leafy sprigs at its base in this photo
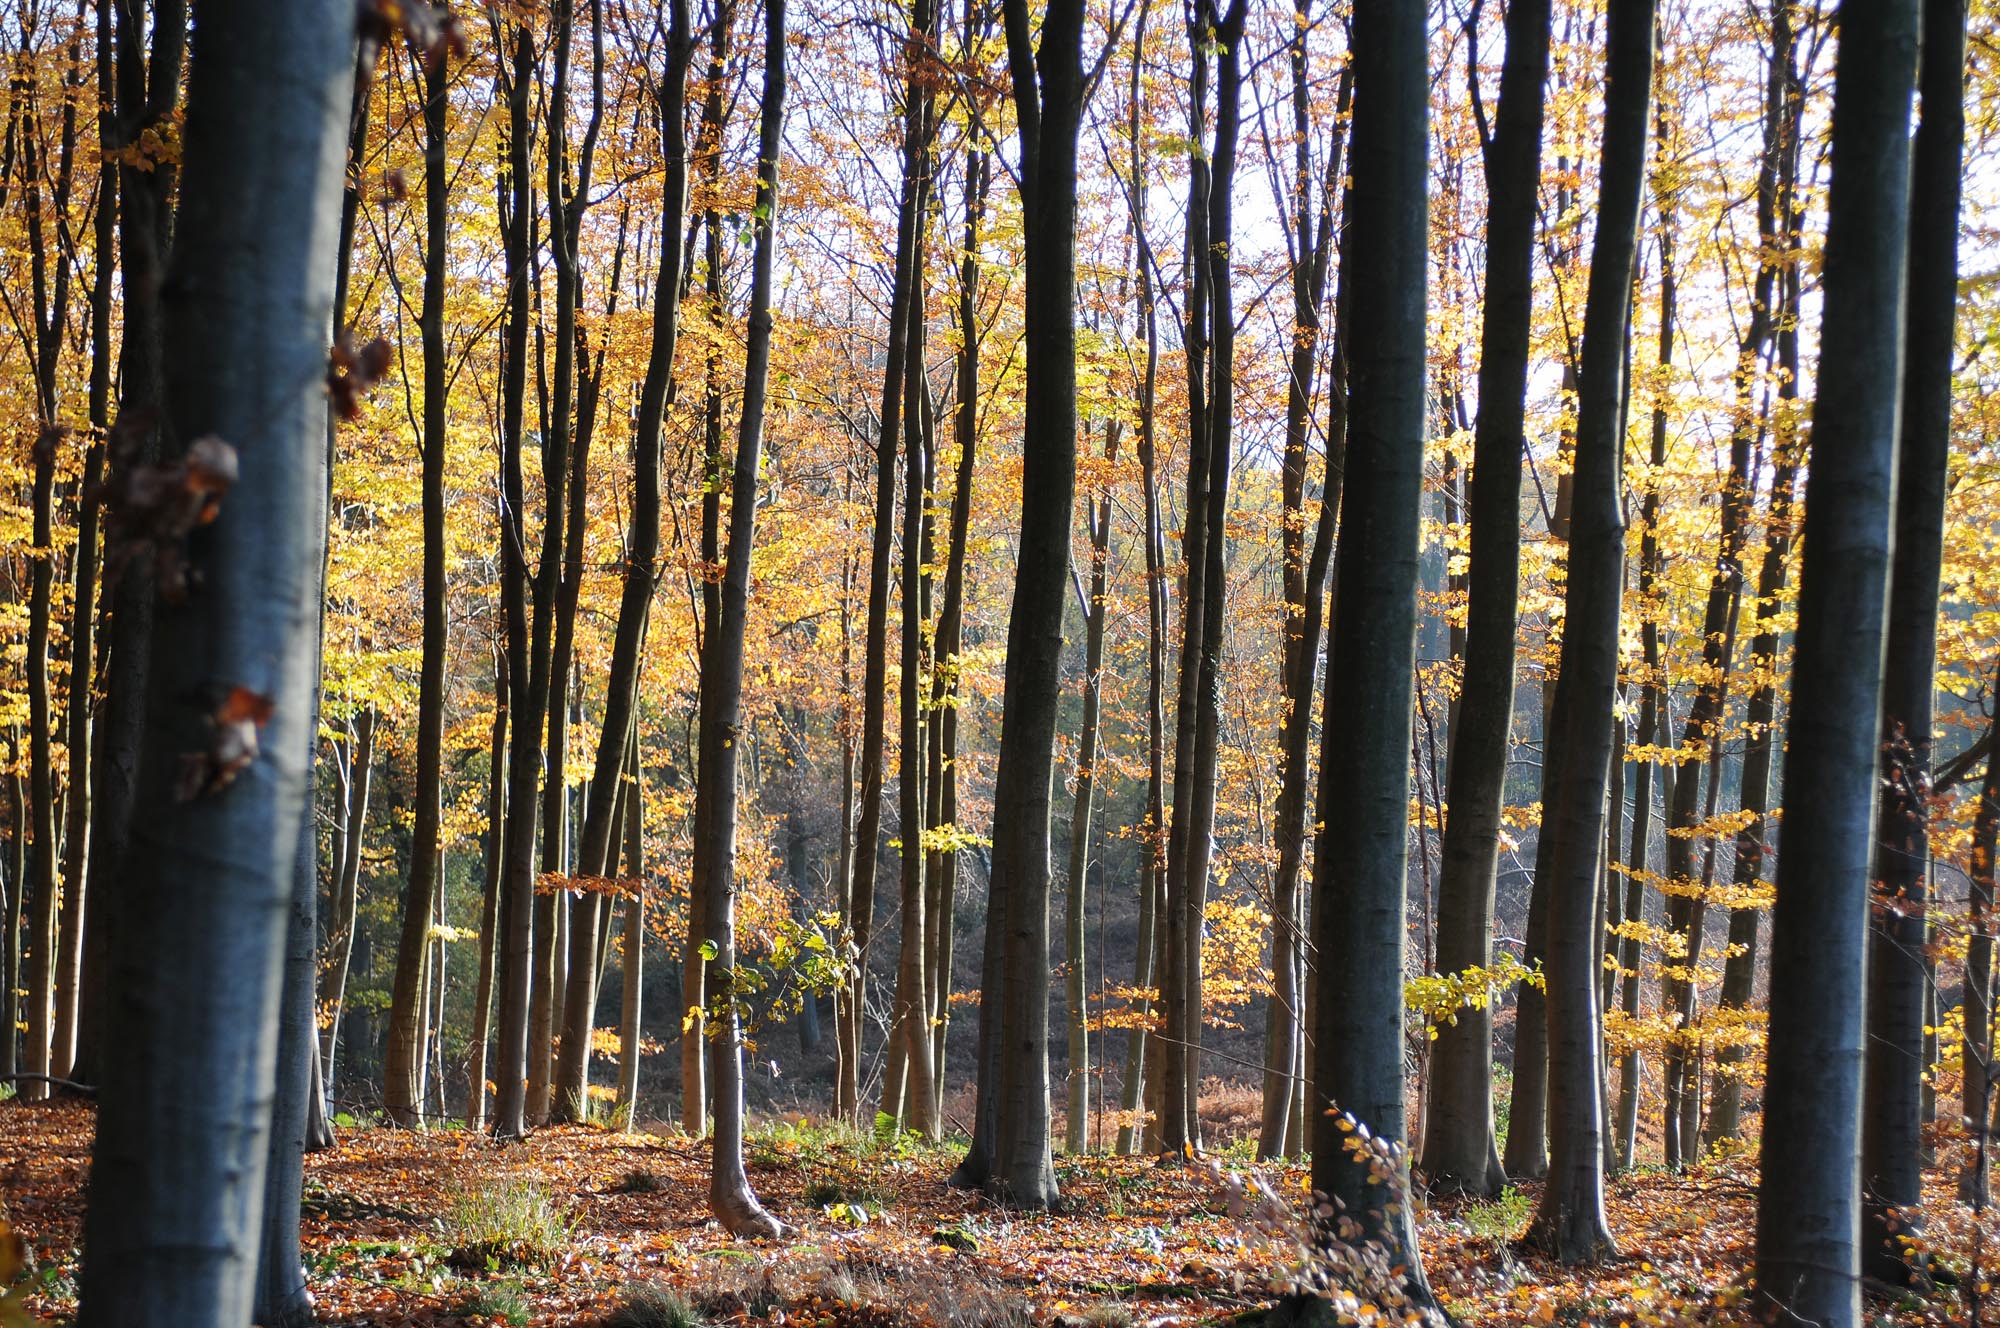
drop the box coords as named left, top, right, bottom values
left=1310, top=0, right=1430, bottom=1304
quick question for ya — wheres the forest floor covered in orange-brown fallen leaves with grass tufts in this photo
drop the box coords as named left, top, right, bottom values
left=0, top=1102, right=1994, bottom=1328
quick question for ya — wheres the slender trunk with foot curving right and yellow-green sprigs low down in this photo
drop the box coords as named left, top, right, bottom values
left=690, top=0, right=786, bottom=1238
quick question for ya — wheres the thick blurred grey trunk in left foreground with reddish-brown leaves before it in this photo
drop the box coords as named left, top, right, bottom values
left=78, top=0, right=354, bottom=1328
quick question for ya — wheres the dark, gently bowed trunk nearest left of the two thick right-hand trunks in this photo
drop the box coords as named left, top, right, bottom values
left=1526, top=0, right=1654, bottom=1264
